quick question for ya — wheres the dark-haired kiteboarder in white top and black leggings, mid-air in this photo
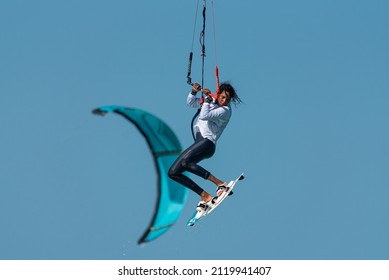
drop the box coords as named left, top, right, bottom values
left=168, top=82, right=241, bottom=211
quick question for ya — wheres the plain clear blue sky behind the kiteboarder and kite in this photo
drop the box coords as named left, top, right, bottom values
left=0, top=0, right=389, bottom=259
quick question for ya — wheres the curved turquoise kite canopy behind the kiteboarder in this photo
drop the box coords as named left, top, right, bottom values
left=93, top=106, right=188, bottom=244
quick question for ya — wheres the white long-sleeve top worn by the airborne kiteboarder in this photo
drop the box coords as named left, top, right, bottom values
left=186, top=92, right=232, bottom=144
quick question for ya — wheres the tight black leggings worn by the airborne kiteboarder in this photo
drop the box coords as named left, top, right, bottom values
left=168, top=133, right=216, bottom=195
